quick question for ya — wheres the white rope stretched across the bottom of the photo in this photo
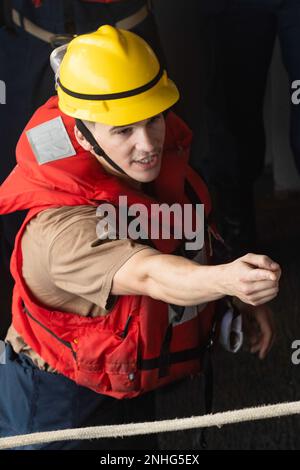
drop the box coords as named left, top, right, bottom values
left=0, top=401, right=300, bottom=449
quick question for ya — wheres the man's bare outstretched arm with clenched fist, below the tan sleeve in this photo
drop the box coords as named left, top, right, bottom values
left=111, top=252, right=281, bottom=306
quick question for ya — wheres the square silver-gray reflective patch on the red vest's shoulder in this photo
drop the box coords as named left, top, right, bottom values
left=26, top=116, right=76, bottom=165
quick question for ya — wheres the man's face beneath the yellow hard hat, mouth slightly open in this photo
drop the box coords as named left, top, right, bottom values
left=78, top=114, right=165, bottom=183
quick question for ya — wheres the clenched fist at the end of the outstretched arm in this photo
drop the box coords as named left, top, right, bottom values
left=218, top=253, right=281, bottom=306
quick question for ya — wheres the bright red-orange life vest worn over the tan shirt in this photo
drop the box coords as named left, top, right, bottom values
left=0, top=97, right=220, bottom=398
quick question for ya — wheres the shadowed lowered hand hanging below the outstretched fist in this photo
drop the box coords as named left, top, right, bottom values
left=234, top=299, right=275, bottom=359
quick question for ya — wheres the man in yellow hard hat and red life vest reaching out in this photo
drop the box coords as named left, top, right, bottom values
left=0, top=25, right=280, bottom=449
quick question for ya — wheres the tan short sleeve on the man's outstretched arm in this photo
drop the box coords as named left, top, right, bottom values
left=48, top=213, right=149, bottom=308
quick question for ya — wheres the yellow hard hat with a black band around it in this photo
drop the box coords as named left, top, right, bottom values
left=57, top=25, right=179, bottom=126
